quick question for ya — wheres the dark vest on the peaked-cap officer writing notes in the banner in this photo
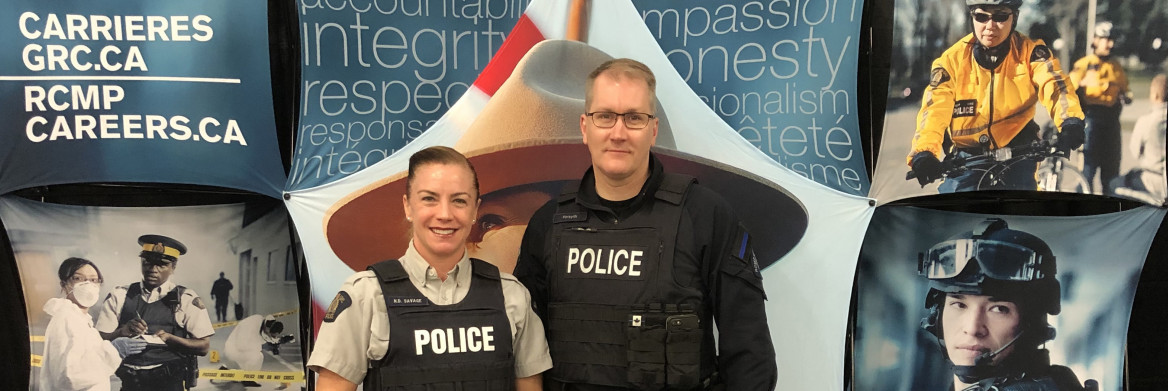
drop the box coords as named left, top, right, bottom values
left=118, top=282, right=194, bottom=366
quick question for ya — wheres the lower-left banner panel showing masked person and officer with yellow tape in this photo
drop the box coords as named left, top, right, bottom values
left=0, top=196, right=304, bottom=390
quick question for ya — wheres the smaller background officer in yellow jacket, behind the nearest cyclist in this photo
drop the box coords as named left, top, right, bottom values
left=1069, top=22, right=1132, bottom=195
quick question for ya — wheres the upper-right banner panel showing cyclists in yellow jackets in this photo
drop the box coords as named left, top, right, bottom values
left=870, top=0, right=1166, bottom=205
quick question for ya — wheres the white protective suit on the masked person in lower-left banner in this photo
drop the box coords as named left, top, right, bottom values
left=37, top=298, right=121, bottom=391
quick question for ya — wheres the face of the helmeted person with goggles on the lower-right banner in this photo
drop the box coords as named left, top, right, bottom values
left=941, top=293, right=1021, bottom=365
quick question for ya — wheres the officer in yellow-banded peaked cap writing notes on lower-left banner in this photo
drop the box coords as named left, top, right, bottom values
left=97, top=235, right=215, bottom=391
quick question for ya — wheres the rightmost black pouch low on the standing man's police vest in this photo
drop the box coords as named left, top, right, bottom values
left=665, top=314, right=702, bottom=390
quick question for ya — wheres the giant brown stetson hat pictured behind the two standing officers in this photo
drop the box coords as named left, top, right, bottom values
left=324, top=40, right=807, bottom=271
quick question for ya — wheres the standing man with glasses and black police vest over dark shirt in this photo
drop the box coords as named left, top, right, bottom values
left=515, top=58, right=778, bottom=390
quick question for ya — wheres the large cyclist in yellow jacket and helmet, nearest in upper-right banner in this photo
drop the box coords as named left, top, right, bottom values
left=908, top=0, right=1084, bottom=193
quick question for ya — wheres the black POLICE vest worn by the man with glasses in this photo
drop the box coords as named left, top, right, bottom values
left=544, top=174, right=703, bottom=390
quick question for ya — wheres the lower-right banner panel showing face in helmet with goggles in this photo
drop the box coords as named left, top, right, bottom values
left=855, top=207, right=1164, bottom=390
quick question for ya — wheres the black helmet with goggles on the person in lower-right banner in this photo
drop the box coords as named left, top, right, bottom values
left=918, top=218, right=1062, bottom=343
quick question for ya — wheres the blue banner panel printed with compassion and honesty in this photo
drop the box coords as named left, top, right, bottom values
left=633, top=0, right=869, bottom=195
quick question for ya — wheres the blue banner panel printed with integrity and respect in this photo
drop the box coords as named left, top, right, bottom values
left=286, top=0, right=529, bottom=189
